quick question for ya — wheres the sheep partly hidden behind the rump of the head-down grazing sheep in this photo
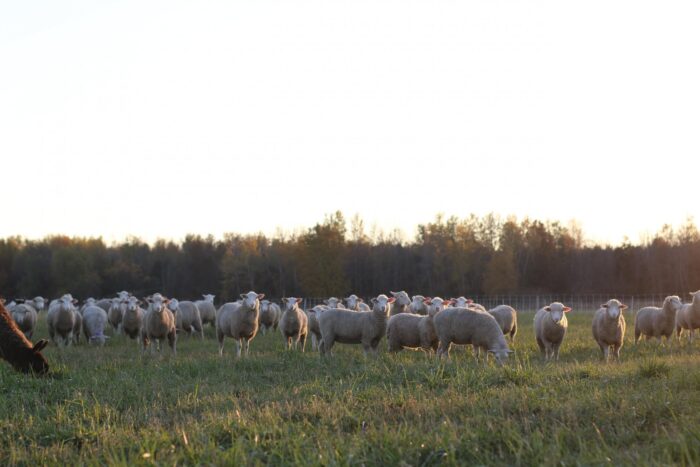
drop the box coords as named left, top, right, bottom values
left=386, top=297, right=450, bottom=352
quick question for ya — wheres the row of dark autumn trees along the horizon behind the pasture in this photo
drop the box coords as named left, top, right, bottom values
left=0, top=212, right=700, bottom=300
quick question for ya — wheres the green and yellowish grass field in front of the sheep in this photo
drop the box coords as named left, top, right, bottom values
left=0, top=313, right=700, bottom=466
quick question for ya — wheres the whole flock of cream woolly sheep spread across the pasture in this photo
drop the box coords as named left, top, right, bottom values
left=0, top=291, right=700, bottom=372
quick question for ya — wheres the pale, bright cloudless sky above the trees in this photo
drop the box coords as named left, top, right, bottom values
left=0, top=0, right=700, bottom=249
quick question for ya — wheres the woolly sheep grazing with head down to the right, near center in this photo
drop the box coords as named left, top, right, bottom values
left=433, top=307, right=512, bottom=365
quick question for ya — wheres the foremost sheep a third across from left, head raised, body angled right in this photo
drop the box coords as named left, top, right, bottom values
left=216, top=291, right=265, bottom=358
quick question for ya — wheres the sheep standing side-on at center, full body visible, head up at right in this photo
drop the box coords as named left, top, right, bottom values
left=318, top=294, right=396, bottom=356
